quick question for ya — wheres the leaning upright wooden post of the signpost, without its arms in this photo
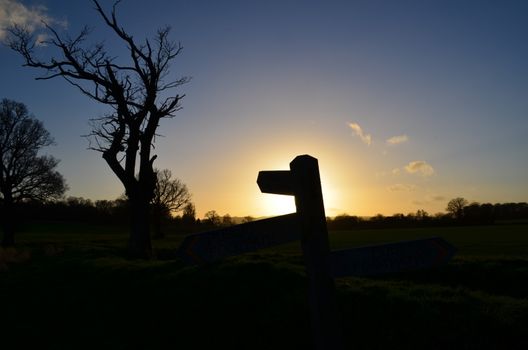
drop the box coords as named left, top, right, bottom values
left=290, top=155, right=343, bottom=349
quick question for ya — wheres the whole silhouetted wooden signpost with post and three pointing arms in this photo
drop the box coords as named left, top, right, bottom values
left=178, top=155, right=455, bottom=349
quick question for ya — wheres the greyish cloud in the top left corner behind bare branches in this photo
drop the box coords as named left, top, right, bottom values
left=0, top=0, right=67, bottom=44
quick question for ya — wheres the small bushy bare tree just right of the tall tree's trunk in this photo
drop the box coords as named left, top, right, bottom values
left=152, top=169, right=191, bottom=238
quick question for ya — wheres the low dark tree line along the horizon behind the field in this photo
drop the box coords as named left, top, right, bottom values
left=9, top=195, right=528, bottom=230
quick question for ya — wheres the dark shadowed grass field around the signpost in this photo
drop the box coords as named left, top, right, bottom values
left=0, top=223, right=528, bottom=349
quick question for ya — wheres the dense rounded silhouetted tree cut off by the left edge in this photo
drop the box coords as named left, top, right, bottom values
left=0, top=99, right=67, bottom=246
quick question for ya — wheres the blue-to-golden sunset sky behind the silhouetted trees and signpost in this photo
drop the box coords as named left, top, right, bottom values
left=0, top=0, right=528, bottom=217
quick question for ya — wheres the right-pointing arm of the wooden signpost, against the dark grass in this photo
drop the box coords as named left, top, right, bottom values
left=330, top=237, right=456, bottom=277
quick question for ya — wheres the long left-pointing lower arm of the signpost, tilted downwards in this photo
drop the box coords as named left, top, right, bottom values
left=177, top=213, right=301, bottom=264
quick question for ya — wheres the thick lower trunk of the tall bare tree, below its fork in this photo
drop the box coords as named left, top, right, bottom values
left=128, top=197, right=152, bottom=259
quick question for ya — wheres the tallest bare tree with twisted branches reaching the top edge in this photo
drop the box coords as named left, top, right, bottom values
left=9, top=0, right=189, bottom=258
